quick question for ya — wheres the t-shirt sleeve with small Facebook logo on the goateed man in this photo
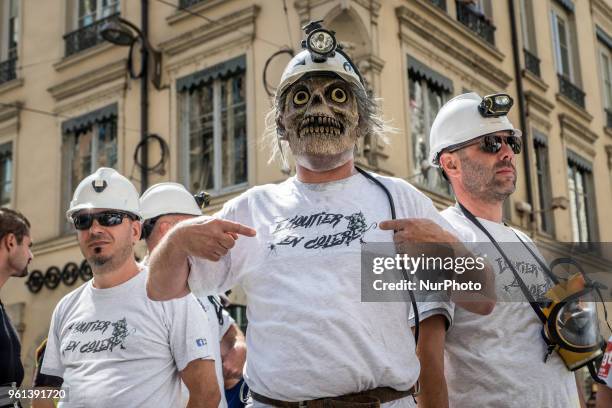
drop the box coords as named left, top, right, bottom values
left=164, top=294, right=214, bottom=371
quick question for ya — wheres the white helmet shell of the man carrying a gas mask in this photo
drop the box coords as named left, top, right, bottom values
left=429, top=92, right=523, bottom=167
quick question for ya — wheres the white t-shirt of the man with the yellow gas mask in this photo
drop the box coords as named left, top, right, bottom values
left=440, top=207, right=578, bottom=408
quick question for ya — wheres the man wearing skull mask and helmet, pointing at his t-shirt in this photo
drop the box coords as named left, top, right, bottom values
left=147, top=24, right=490, bottom=407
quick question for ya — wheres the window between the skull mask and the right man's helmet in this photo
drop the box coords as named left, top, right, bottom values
left=408, top=57, right=452, bottom=195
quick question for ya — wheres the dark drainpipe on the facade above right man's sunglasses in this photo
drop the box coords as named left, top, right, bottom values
left=508, top=0, right=536, bottom=233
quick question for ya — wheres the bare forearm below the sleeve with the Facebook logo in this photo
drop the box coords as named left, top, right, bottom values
left=180, top=359, right=221, bottom=408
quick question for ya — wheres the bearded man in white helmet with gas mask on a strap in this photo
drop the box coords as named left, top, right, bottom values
left=421, top=93, right=579, bottom=408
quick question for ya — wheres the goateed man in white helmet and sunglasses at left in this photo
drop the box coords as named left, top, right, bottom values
left=35, top=168, right=220, bottom=407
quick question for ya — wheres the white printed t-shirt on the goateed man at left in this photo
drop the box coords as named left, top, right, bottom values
left=41, top=269, right=216, bottom=408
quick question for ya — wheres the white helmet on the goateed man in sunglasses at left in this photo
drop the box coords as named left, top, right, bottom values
left=66, top=167, right=142, bottom=221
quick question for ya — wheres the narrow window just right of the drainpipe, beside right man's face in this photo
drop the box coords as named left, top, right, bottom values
left=533, top=131, right=554, bottom=235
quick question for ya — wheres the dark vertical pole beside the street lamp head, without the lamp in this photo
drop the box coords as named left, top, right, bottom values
left=140, top=0, right=149, bottom=194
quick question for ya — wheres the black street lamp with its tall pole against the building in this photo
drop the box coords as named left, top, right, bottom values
left=100, top=11, right=161, bottom=192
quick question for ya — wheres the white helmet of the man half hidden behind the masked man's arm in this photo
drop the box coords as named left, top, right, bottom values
left=140, top=182, right=202, bottom=221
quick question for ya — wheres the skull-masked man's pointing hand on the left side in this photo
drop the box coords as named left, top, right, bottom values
left=176, top=216, right=256, bottom=261
